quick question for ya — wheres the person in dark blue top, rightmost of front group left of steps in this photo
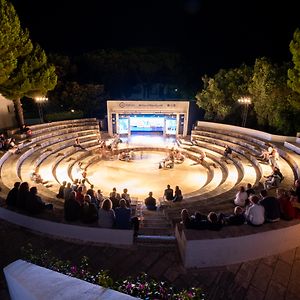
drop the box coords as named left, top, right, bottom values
left=115, top=199, right=139, bottom=236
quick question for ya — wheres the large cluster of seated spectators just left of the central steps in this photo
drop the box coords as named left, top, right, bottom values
left=57, top=179, right=139, bottom=236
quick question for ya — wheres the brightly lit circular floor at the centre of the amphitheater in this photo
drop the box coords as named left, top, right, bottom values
left=87, top=151, right=207, bottom=200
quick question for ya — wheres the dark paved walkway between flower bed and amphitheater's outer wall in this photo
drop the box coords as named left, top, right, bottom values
left=0, top=221, right=300, bottom=300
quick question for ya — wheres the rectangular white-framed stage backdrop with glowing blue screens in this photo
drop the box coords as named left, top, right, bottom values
left=107, top=100, right=189, bottom=136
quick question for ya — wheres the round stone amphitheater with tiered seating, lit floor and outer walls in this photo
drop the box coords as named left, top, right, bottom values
left=0, top=118, right=300, bottom=300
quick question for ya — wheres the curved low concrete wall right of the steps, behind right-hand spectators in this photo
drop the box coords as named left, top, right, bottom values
left=175, top=220, right=300, bottom=268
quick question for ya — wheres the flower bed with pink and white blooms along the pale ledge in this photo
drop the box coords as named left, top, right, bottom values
left=22, top=244, right=204, bottom=300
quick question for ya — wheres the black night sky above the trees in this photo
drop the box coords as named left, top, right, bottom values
left=12, top=0, right=300, bottom=75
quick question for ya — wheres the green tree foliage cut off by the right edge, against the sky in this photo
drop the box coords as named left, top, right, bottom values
left=288, top=28, right=300, bottom=95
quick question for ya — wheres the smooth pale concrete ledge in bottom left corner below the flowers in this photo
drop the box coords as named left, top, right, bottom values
left=3, top=260, right=136, bottom=300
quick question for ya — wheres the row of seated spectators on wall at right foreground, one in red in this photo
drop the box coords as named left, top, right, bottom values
left=181, top=180, right=300, bottom=230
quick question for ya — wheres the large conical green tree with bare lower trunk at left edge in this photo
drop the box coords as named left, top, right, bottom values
left=0, top=0, right=57, bottom=126
